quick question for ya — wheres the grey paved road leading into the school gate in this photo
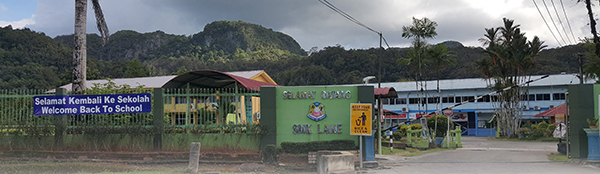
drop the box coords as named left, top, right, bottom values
left=366, top=137, right=600, bottom=174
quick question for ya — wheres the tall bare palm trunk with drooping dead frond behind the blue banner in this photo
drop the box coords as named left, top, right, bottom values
left=71, top=0, right=110, bottom=94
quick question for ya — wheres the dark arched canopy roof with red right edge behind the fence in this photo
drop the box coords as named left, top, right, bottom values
left=162, top=69, right=279, bottom=91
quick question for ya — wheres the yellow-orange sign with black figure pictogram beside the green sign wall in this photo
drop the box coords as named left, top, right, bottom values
left=350, top=103, right=372, bottom=136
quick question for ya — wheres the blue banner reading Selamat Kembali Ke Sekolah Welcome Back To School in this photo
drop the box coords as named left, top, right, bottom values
left=33, top=93, right=152, bottom=115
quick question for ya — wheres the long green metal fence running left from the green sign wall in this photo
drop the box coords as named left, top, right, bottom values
left=0, top=88, right=261, bottom=150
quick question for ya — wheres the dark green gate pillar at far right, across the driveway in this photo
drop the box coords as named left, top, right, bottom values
left=568, top=84, right=600, bottom=159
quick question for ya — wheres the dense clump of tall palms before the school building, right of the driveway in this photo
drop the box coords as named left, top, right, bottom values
left=477, top=18, right=546, bottom=136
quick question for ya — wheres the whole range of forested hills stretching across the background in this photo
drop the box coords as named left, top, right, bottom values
left=0, top=21, right=587, bottom=89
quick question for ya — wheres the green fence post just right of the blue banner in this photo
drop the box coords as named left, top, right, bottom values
left=152, top=88, right=165, bottom=150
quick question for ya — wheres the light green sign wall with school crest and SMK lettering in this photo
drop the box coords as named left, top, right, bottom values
left=274, top=86, right=358, bottom=146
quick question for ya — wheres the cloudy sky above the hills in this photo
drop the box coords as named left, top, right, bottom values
left=0, top=0, right=600, bottom=50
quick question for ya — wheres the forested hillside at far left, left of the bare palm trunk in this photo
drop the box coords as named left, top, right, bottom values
left=0, top=25, right=73, bottom=89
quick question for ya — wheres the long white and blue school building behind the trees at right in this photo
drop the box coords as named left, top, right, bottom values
left=376, top=73, right=596, bottom=136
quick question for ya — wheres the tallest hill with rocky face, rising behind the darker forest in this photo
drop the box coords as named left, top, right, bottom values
left=54, top=21, right=306, bottom=60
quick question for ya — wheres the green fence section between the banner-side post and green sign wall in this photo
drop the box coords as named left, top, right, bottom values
left=163, top=88, right=259, bottom=125
